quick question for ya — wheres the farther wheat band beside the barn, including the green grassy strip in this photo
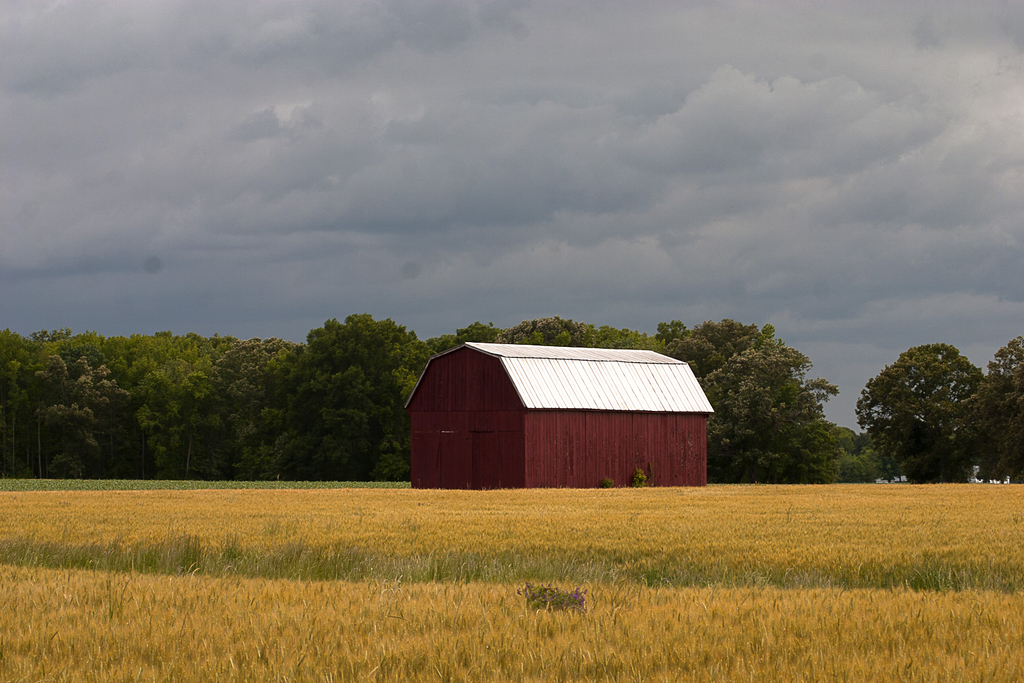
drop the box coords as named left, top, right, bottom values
left=0, top=484, right=1024, bottom=592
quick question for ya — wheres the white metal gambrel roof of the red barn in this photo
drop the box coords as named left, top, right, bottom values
left=410, top=342, right=714, bottom=413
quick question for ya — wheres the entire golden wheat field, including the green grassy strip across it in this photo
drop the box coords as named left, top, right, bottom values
left=0, top=485, right=1024, bottom=683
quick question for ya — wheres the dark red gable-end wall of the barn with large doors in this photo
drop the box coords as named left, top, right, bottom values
left=408, top=348, right=525, bottom=488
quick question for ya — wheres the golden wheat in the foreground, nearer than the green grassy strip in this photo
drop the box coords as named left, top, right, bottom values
left=0, top=566, right=1024, bottom=683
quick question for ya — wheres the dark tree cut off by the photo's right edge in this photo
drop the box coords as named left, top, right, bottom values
left=971, top=336, right=1024, bottom=479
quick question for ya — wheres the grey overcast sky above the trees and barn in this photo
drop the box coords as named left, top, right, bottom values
left=0, top=0, right=1024, bottom=427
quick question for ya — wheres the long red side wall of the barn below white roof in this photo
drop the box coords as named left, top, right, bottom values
left=525, top=411, right=708, bottom=487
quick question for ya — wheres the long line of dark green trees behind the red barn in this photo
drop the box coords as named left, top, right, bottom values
left=0, top=313, right=1024, bottom=483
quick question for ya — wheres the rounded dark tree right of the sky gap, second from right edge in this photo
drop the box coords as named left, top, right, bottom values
left=857, top=344, right=983, bottom=482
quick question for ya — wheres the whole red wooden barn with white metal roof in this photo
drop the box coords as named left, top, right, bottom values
left=406, top=343, right=713, bottom=488
